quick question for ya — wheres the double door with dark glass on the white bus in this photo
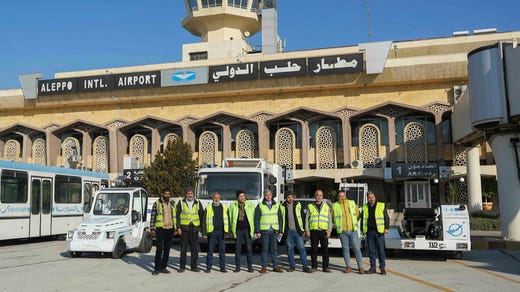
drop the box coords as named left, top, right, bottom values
left=29, top=176, right=52, bottom=237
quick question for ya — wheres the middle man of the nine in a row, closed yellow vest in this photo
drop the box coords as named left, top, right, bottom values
left=255, top=190, right=284, bottom=274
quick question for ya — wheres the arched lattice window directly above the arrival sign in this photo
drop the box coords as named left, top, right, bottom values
left=404, top=122, right=427, bottom=163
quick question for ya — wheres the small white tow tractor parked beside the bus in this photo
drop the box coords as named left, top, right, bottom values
left=67, top=188, right=152, bottom=258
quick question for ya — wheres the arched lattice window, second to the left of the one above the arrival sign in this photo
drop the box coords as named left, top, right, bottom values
left=316, top=126, right=337, bottom=169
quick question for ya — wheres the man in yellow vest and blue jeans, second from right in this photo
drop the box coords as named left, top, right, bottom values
left=332, top=191, right=365, bottom=274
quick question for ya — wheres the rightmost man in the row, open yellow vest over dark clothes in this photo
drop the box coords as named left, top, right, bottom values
left=361, top=191, right=390, bottom=275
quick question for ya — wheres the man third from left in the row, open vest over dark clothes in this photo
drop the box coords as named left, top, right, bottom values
left=202, top=192, right=229, bottom=273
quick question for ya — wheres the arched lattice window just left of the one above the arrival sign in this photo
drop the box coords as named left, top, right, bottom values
left=359, top=124, right=381, bottom=168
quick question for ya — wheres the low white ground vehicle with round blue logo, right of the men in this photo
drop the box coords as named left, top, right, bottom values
left=385, top=205, right=471, bottom=256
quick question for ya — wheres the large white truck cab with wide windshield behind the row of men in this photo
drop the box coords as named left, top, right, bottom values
left=195, top=158, right=285, bottom=208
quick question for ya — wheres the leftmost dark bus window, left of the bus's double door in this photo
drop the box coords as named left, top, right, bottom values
left=0, top=170, right=29, bottom=203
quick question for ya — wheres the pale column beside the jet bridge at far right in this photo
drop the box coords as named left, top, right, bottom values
left=466, top=146, right=482, bottom=211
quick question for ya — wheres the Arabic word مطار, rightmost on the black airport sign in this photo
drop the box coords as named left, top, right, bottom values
left=308, top=53, right=363, bottom=75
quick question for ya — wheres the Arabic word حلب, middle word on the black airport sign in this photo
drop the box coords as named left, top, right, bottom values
left=260, top=58, right=307, bottom=79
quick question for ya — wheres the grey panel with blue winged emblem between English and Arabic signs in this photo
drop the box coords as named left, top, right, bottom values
left=161, top=67, right=209, bottom=87
